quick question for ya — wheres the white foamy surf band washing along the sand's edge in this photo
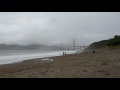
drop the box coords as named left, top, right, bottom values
left=0, top=51, right=78, bottom=65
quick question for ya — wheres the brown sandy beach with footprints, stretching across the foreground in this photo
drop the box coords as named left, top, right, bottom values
left=0, top=50, right=120, bottom=78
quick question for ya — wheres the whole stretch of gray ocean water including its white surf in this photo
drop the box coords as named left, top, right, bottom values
left=0, top=50, right=82, bottom=65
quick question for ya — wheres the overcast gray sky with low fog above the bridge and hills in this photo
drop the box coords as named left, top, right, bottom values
left=0, top=12, right=120, bottom=46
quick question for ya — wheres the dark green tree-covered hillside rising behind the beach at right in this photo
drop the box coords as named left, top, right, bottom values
left=87, top=35, right=120, bottom=50
